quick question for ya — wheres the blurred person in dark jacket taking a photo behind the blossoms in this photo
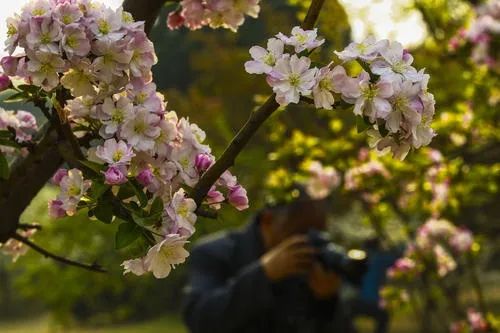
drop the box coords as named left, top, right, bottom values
left=183, top=200, right=340, bottom=333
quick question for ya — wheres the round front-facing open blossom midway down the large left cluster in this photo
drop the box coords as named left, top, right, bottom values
left=120, top=109, right=161, bottom=151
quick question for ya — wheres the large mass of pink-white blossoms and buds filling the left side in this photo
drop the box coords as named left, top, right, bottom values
left=0, top=0, right=248, bottom=278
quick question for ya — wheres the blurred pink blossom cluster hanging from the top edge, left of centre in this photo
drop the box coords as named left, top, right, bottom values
left=167, top=0, right=260, bottom=31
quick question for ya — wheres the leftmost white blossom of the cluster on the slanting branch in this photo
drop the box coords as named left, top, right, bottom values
left=245, top=38, right=285, bottom=74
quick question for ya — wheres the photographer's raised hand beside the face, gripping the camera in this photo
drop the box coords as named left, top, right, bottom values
left=260, top=235, right=316, bottom=281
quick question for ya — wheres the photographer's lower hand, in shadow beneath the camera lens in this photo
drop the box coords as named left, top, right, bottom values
left=309, top=262, right=341, bottom=300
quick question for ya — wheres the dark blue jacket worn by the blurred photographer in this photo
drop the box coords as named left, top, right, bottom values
left=184, top=222, right=336, bottom=333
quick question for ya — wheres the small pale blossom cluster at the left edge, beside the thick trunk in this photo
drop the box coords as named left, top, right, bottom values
left=0, top=108, right=38, bottom=154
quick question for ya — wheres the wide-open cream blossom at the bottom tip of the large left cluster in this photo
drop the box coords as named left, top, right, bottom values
left=144, top=234, right=189, bottom=279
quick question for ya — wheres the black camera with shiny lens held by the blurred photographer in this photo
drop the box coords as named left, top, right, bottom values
left=307, top=229, right=368, bottom=285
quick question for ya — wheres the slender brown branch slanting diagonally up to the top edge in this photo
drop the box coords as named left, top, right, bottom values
left=190, top=0, right=325, bottom=207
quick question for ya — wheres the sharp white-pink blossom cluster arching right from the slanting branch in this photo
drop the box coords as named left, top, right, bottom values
left=245, top=27, right=435, bottom=159
